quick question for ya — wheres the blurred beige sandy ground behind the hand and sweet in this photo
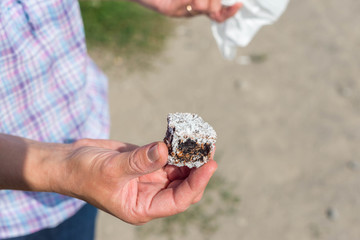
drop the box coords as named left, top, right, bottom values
left=90, top=0, right=360, bottom=240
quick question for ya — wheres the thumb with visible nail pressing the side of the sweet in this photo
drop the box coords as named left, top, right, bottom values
left=120, top=142, right=168, bottom=178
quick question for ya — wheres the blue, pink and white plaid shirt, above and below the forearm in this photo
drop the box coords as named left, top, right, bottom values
left=0, top=0, right=109, bottom=239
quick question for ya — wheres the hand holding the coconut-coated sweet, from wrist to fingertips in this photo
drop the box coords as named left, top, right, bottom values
left=52, top=140, right=217, bottom=224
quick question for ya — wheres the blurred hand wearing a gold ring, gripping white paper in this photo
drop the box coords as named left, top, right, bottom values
left=134, top=0, right=242, bottom=22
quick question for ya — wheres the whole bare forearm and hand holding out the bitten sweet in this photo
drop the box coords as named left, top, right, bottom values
left=0, top=134, right=217, bottom=225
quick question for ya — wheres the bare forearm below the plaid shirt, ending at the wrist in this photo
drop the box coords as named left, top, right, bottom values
left=0, top=134, right=67, bottom=191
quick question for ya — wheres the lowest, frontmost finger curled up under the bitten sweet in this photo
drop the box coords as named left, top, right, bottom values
left=149, top=160, right=217, bottom=218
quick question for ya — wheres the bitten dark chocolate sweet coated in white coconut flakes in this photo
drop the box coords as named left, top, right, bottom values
left=164, top=113, right=216, bottom=168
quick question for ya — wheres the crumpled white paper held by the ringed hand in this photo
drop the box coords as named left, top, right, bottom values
left=211, top=0, right=289, bottom=59
